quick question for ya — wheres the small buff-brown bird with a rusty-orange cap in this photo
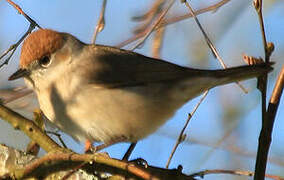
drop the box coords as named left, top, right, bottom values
left=9, top=29, right=273, bottom=151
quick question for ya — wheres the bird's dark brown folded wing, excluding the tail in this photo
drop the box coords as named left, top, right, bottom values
left=83, top=45, right=203, bottom=88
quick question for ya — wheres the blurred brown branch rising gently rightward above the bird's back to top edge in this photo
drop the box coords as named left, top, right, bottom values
left=116, top=0, right=230, bottom=48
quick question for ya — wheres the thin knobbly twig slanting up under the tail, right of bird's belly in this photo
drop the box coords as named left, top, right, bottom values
left=166, top=90, right=209, bottom=168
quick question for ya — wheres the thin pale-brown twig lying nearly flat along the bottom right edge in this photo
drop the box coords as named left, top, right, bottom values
left=190, top=169, right=284, bottom=180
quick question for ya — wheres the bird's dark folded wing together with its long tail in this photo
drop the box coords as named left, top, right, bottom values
left=80, top=45, right=273, bottom=88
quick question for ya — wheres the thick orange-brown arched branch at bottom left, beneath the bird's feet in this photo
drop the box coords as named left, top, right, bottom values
left=12, top=153, right=155, bottom=179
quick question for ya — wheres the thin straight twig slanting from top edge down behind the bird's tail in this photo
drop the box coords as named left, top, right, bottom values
left=183, top=0, right=248, bottom=93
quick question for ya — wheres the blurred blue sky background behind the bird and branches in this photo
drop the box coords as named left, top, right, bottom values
left=0, top=0, right=284, bottom=179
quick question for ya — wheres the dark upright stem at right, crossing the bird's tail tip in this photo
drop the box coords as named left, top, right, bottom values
left=253, top=0, right=277, bottom=180
